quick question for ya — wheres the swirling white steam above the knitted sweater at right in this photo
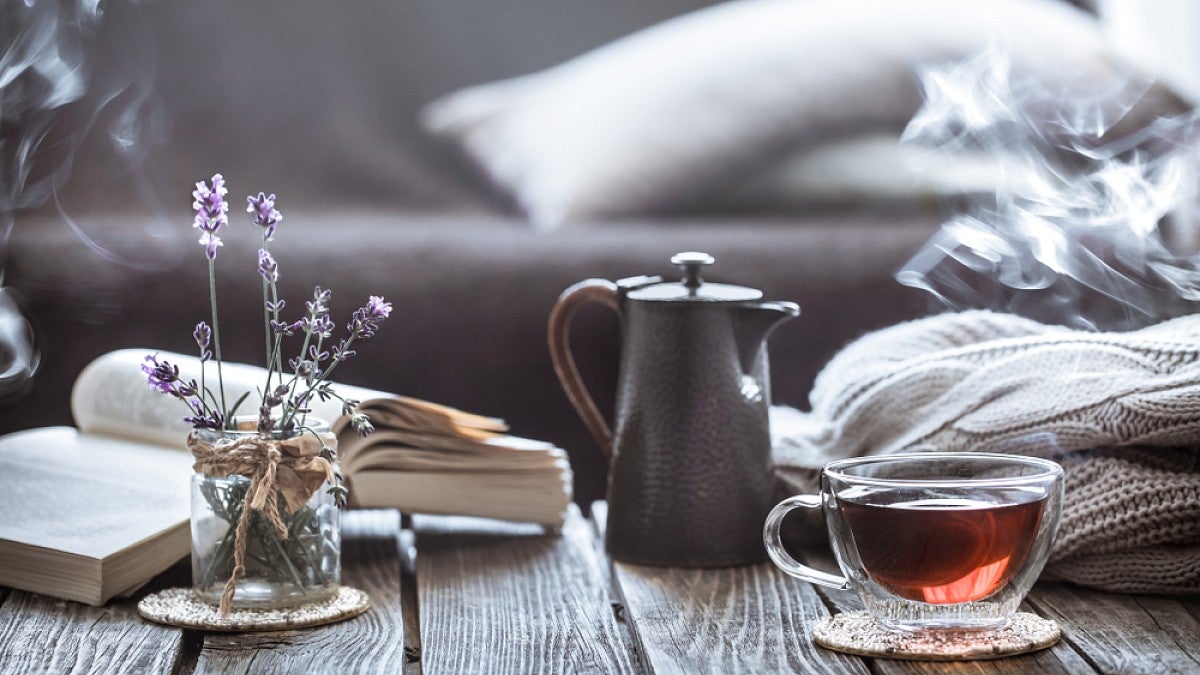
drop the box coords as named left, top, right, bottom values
left=896, top=49, right=1200, bottom=330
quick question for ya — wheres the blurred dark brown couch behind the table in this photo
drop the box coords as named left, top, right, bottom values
left=0, top=0, right=940, bottom=503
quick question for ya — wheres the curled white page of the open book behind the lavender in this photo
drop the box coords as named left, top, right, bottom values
left=71, top=348, right=394, bottom=450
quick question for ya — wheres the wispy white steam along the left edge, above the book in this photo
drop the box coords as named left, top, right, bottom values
left=0, top=0, right=163, bottom=398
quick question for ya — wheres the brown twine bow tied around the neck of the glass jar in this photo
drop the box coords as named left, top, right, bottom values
left=187, top=432, right=334, bottom=616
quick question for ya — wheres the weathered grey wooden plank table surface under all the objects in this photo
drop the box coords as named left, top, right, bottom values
left=0, top=503, right=1200, bottom=674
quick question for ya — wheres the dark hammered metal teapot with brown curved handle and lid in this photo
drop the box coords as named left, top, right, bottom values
left=550, top=252, right=800, bottom=567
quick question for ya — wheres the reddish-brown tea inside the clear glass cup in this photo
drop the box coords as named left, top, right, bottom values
left=839, top=498, right=1044, bottom=604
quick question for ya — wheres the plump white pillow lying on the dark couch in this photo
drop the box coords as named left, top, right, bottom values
left=422, top=0, right=1137, bottom=229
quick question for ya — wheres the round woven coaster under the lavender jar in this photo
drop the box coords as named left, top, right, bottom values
left=138, top=586, right=371, bottom=632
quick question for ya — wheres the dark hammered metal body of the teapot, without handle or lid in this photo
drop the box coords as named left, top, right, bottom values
left=606, top=301, right=775, bottom=567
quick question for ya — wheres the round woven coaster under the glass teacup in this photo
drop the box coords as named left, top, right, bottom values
left=812, top=611, right=1062, bottom=661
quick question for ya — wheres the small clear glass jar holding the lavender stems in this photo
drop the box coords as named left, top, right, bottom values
left=192, top=418, right=342, bottom=609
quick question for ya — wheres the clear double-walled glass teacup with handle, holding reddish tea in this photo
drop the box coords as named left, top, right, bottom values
left=763, top=453, right=1063, bottom=631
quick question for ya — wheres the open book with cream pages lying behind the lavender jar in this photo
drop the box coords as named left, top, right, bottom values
left=0, top=350, right=572, bottom=604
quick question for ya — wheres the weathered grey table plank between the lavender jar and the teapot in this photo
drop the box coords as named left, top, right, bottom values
left=414, top=507, right=634, bottom=674
